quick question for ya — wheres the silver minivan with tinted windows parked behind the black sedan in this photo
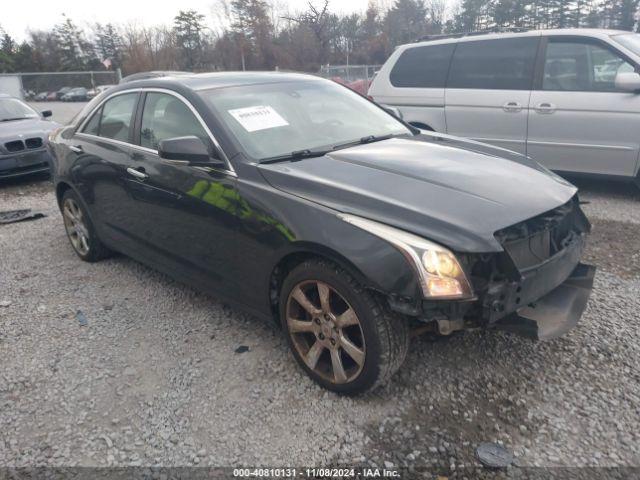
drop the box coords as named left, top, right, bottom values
left=369, top=29, right=640, bottom=181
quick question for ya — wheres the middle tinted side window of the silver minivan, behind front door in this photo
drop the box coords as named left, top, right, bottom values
left=447, top=37, right=539, bottom=90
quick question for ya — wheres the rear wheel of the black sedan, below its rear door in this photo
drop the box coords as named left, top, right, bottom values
left=60, top=189, right=112, bottom=262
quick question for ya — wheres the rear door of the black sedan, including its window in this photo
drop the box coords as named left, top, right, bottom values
left=73, top=92, right=139, bottom=251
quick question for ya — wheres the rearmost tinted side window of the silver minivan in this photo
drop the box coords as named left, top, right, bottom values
left=389, top=43, right=456, bottom=88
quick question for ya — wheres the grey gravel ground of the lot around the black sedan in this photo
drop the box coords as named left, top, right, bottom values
left=0, top=174, right=640, bottom=476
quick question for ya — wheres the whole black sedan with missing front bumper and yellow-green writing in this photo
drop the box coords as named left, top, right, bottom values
left=47, top=73, right=594, bottom=393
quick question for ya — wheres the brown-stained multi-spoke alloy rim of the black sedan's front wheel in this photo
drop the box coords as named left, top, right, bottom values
left=286, top=280, right=366, bottom=384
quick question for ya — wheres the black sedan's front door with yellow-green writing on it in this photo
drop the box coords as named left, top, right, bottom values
left=127, top=91, right=240, bottom=297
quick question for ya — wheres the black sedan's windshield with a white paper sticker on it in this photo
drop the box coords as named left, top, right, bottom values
left=201, top=80, right=411, bottom=160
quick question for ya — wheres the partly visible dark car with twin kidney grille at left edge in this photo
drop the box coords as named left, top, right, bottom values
left=0, top=94, right=60, bottom=179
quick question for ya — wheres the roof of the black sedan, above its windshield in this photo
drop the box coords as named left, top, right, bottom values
left=119, top=72, right=319, bottom=90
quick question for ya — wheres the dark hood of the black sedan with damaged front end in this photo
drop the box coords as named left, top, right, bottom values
left=258, top=135, right=576, bottom=252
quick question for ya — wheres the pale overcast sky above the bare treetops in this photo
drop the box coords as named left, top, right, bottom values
left=0, top=0, right=378, bottom=41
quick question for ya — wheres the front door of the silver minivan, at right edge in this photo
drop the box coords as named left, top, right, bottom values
left=527, top=36, right=640, bottom=176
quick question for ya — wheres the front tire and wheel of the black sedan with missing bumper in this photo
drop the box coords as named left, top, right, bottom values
left=279, top=260, right=409, bottom=395
